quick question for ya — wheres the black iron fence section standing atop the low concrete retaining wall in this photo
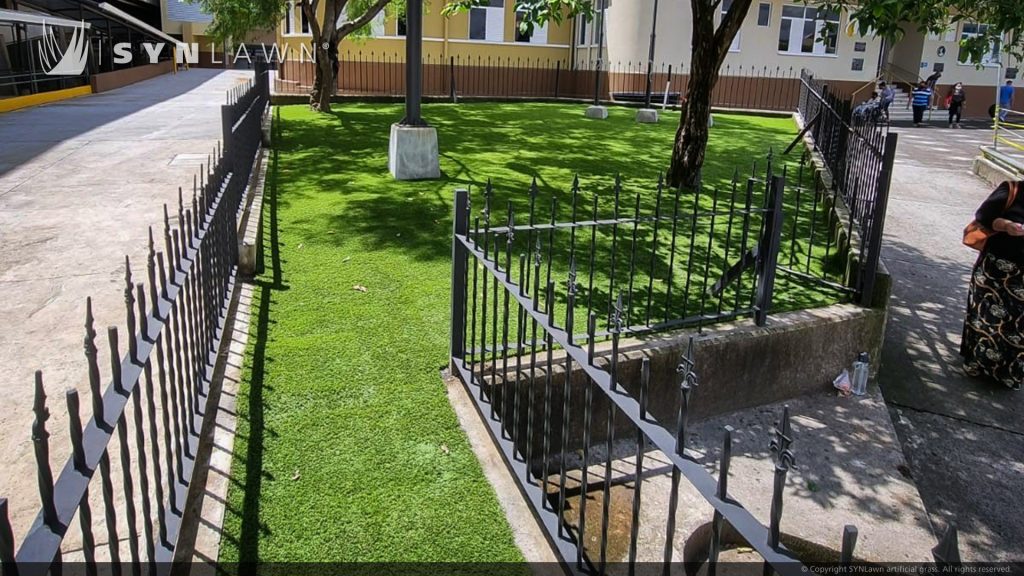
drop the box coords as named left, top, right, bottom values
left=455, top=168, right=783, bottom=349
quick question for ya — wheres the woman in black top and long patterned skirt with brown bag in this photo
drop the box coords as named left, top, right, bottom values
left=961, top=182, right=1024, bottom=389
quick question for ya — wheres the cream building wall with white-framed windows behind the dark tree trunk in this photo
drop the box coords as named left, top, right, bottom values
left=577, top=0, right=882, bottom=82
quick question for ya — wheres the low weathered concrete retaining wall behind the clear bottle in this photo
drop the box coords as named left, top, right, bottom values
left=477, top=273, right=891, bottom=465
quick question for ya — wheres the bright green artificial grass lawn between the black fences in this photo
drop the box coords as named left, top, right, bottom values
left=220, top=104, right=836, bottom=562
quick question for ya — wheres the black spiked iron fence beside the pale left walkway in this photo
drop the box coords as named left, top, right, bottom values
left=0, top=63, right=269, bottom=576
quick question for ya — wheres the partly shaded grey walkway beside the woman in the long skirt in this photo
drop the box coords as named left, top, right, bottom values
left=880, top=117, right=1024, bottom=561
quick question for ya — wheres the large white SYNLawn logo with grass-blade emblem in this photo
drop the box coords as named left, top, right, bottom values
left=39, top=22, right=316, bottom=76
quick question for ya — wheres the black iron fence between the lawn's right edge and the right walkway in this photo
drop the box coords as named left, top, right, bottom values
left=791, top=70, right=898, bottom=304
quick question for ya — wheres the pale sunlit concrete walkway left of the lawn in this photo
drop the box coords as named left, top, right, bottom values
left=0, top=70, right=251, bottom=541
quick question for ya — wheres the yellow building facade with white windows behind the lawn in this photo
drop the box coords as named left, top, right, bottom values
left=276, top=0, right=573, bottom=66
